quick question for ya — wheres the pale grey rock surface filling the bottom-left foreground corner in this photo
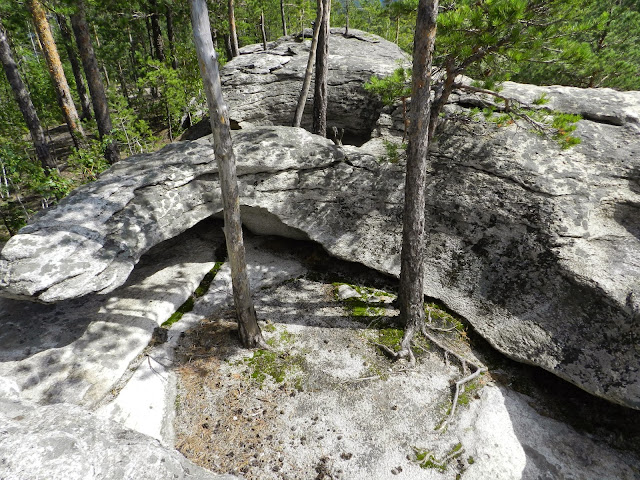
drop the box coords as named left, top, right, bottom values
left=0, top=378, right=237, bottom=480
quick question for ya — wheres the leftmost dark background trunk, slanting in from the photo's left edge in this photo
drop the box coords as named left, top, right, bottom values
left=0, top=23, right=56, bottom=171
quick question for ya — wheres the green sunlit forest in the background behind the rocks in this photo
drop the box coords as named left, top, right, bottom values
left=0, top=0, right=640, bottom=237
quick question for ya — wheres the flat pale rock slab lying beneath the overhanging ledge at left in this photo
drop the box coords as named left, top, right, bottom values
left=0, top=222, right=224, bottom=406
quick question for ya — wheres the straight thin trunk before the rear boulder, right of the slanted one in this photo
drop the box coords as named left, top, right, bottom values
left=311, top=0, right=331, bottom=137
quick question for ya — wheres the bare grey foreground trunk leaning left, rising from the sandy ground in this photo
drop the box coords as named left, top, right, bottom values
left=190, top=0, right=266, bottom=348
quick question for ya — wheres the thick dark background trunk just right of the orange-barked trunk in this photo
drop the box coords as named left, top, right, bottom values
left=71, top=0, right=120, bottom=164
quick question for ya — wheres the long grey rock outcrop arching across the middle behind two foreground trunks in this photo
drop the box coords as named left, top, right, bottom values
left=0, top=31, right=640, bottom=408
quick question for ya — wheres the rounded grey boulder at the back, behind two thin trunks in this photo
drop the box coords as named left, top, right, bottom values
left=190, top=28, right=409, bottom=143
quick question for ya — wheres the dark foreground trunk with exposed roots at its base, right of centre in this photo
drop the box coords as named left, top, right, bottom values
left=398, top=0, right=438, bottom=360
